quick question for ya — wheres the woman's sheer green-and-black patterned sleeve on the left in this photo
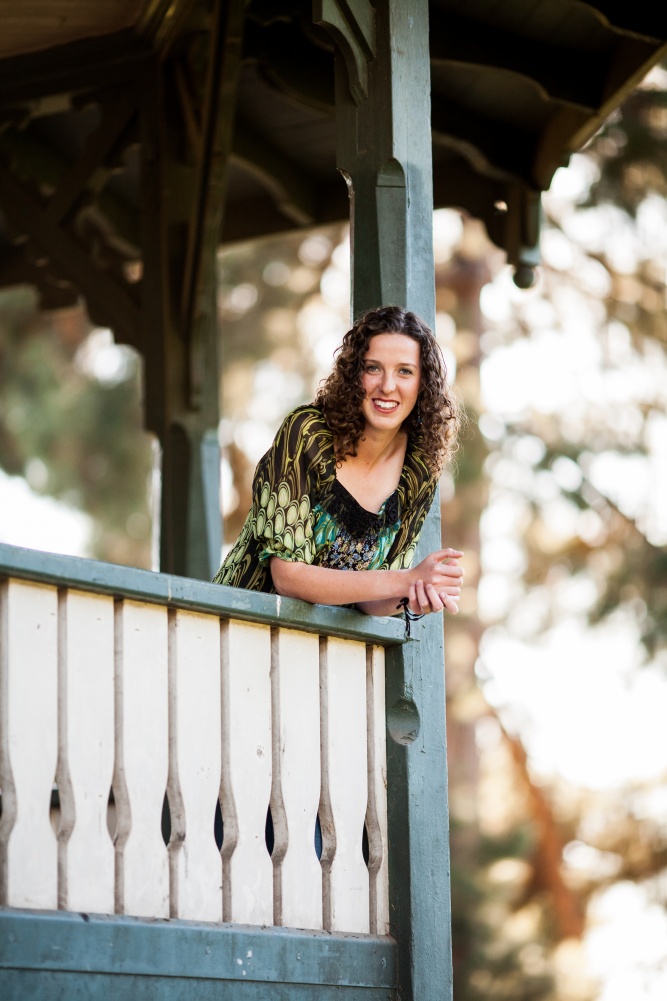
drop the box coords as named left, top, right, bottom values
left=252, top=406, right=332, bottom=567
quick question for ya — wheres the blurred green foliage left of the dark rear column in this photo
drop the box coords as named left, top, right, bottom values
left=0, top=288, right=151, bottom=567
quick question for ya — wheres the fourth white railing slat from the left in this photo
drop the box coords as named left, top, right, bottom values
left=168, top=611, right=222, bottom=921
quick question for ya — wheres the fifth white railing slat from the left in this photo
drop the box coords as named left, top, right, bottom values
left=222, top=620, right=273, bottom=925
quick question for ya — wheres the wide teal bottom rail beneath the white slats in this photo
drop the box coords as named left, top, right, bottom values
left=0, top=909, right=396, bottom=1001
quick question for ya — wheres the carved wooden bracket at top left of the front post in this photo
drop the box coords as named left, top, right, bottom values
left=312, top=0, right=377, bottom=104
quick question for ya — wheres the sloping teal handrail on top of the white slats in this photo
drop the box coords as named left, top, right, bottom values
left=0, top=543, right=405, bottom=647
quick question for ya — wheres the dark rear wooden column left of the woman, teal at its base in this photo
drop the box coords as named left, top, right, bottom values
left=141, top=0, right=244, bottom=580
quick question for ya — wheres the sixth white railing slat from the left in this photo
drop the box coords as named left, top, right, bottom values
left=271, top=630, right=322, bottom=928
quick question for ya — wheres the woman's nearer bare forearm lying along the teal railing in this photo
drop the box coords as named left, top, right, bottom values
left=270, top=557, right=404, bottom=604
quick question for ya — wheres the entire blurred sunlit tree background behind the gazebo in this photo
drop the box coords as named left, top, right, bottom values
left=0, top=69, right=667, bottom=1001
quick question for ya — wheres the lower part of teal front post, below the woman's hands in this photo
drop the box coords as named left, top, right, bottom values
left=385, top=556, right=453, bottom=1001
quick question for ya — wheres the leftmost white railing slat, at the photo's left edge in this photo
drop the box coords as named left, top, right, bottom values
left=0, top=581, right=57, bottom=910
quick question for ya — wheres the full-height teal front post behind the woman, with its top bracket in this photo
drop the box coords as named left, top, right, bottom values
left=314, top=0, right=452, bottom=1001
